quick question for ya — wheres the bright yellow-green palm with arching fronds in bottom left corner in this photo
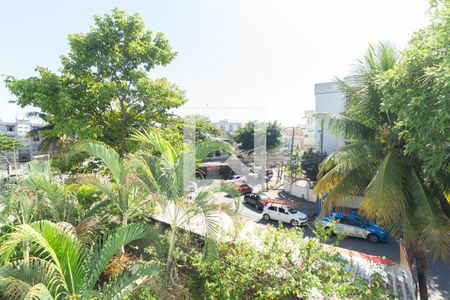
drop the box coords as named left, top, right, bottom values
left=0, top=221, right=159, bottom=299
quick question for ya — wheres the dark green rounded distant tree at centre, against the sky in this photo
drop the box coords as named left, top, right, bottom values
left=233, top=121, right=281, bottom=151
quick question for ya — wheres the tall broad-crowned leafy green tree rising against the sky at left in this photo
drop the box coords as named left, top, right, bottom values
left=5, top=9, right=186, bottom=156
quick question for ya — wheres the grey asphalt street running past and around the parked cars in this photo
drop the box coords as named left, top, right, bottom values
left=234, top=190, right=450, bottom=300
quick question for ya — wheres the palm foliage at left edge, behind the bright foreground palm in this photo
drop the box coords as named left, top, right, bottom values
left=1, top=160, right=110, bottom=242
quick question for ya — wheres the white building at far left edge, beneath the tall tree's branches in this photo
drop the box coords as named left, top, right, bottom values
left=0, top=119, right=44, bottom=162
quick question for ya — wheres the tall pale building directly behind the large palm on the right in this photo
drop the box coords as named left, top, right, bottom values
left=314, top=82, right=345, bottom=153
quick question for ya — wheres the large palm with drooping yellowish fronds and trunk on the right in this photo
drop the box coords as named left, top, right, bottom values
left=314, top=44, right=450, bottom=299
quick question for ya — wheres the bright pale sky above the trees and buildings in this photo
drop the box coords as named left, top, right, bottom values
left=0, top=0, right=429, bottom=126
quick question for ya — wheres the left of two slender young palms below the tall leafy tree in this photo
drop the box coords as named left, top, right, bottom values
left=71, top=141, right=151, bottom=226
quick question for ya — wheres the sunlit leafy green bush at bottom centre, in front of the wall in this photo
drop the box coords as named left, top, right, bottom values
left=191, top=229, right=392, bottom=299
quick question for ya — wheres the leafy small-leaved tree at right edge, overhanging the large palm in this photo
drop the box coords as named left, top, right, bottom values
left=380, top=0, right=450, bottom=175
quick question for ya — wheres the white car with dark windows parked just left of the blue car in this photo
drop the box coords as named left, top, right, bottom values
left=263, top=203, right=308, bottom=226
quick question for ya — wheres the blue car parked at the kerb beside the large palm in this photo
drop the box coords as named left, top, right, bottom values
left=319, top=212, right=389, bottom=243
